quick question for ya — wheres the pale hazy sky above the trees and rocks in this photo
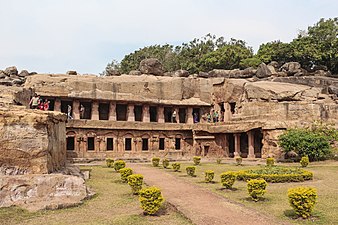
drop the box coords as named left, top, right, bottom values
left=0, top=0, right=338, bottom=74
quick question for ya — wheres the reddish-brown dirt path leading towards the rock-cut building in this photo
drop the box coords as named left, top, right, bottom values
left=129, top=164, right=284, bottom=225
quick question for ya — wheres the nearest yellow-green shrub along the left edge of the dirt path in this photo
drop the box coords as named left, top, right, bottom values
left=139, top=187, right=164, bottom=215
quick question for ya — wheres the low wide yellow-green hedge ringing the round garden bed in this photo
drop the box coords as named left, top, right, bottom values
left=237, top=166, right=313, bottom=183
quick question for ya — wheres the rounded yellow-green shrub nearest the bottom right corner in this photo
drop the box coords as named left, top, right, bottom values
left=288, top=187, right=317, bottom=218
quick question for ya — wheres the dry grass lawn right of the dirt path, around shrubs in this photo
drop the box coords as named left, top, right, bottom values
left=158, top=161, right=338, bottom=225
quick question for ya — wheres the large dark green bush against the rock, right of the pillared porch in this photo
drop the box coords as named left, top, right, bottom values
left=279, top=128, right=331, bottom=161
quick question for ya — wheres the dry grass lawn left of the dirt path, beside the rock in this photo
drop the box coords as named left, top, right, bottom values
left=0, top=166, right=191, bottom=225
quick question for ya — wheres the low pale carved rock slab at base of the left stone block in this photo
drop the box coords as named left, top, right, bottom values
left=0, top=174, right=92, bottom=211
